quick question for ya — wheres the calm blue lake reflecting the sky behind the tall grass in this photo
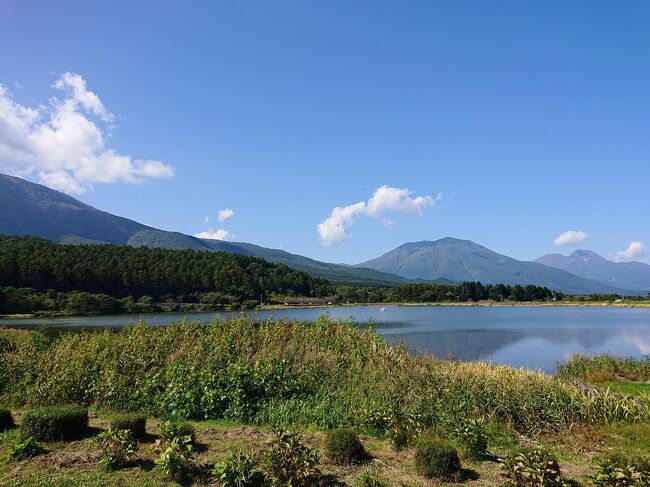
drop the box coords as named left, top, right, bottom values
left=0, top=306, right=650, bottom=372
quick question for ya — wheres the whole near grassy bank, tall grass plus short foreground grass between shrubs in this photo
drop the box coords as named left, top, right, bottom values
left=0, top=318, right=650, bottom=487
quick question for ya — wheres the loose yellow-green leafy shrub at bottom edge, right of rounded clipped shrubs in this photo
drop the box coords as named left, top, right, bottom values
left=501, top=447, right=569, bottom=487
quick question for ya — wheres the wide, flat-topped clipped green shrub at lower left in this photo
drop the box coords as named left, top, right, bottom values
left=21, top=406, right=88, bottom=441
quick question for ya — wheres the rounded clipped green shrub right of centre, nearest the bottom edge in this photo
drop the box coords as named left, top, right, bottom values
left=415, top=436, right=461, bottom=480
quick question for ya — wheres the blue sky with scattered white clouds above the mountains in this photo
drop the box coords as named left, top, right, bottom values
left=0, top=0, right=650, bottom=263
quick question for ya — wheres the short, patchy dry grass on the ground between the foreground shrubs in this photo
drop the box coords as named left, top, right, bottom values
left=0, top=415, right=650, bottom=487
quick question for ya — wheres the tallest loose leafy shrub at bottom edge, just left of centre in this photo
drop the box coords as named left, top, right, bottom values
left=264, top=430, right=320, bottom=486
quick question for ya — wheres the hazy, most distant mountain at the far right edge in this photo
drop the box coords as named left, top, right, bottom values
left=535, top=250, right=650, bottom=293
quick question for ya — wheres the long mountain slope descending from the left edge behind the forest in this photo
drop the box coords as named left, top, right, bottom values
left=0, top=174, right=406, bottom=286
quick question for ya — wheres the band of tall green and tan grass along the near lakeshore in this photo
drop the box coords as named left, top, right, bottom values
left=0, top=318, right=650, bottom=432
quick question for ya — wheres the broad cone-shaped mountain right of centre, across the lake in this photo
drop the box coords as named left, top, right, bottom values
left=357, top=238, right=630, bottom=294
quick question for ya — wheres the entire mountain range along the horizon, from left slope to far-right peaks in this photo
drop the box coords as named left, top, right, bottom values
left=0, top=174, right=650, bottom=294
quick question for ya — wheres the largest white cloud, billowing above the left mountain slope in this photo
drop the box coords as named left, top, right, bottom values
left=0, top=73, right=174, bottom=194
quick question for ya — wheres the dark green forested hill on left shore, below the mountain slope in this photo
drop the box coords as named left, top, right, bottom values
left=0, top=236, right=332, bottom=302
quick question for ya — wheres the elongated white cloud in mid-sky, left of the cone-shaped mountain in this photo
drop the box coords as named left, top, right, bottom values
left=316, top=185, right=442, bottom=246
